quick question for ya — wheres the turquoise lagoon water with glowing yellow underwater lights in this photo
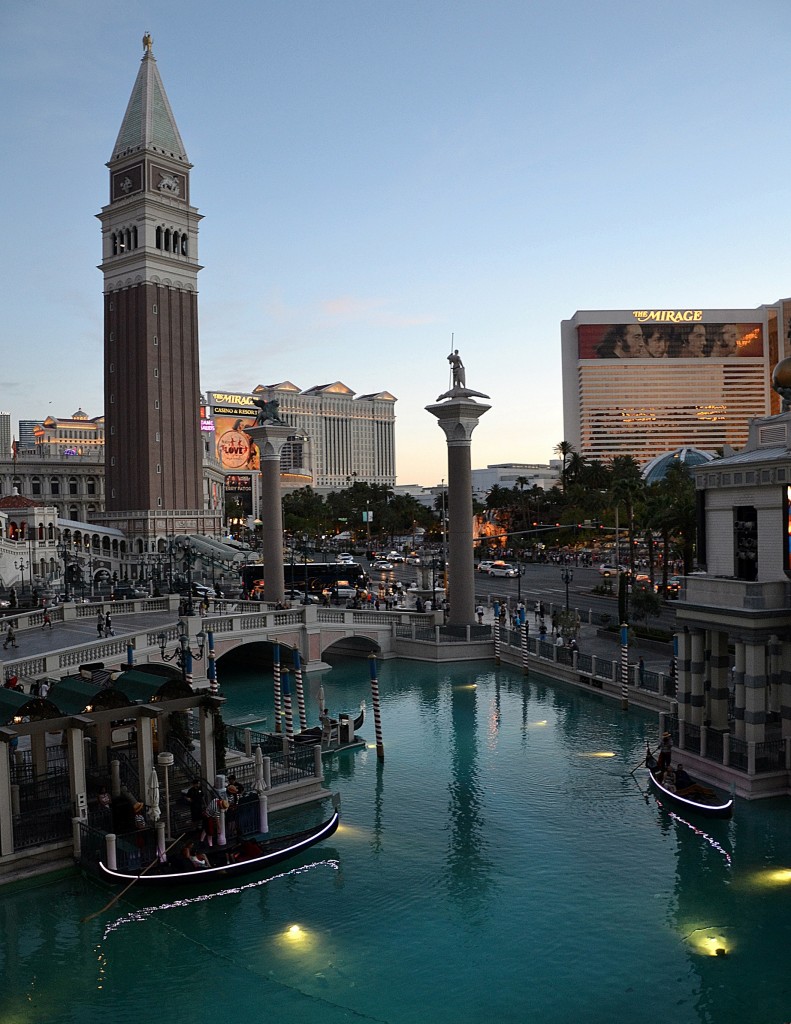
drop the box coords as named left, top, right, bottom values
left=0, top=660, right=791, bottom=1024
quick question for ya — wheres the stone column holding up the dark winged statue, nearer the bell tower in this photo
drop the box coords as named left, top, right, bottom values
left=247, top=423, right=294, bottom=604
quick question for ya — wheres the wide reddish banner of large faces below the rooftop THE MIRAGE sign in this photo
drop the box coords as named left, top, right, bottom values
left=577, top=325, right=763, bottom=359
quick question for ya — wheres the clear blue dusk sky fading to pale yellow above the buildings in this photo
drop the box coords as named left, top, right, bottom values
left=0, top=0, right=791, bottom=484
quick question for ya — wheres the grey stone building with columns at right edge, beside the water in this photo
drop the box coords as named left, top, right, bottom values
left=671, top=399, right=791, bottom=797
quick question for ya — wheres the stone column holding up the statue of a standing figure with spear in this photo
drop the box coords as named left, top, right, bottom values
left=426, top=397, right=492, bottom=626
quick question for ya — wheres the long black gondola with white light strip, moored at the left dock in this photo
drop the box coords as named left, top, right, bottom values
left=98, top=807, right=340, bottom=888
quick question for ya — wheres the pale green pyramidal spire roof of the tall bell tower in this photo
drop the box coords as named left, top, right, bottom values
left=111, top=49, right=189, bottom=163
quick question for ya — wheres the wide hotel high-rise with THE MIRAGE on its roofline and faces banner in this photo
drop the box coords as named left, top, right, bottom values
left=560, top=300, right=791, bottom=464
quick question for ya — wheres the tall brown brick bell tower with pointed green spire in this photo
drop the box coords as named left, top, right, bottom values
left=98, top=33, right=220, bottom=550
